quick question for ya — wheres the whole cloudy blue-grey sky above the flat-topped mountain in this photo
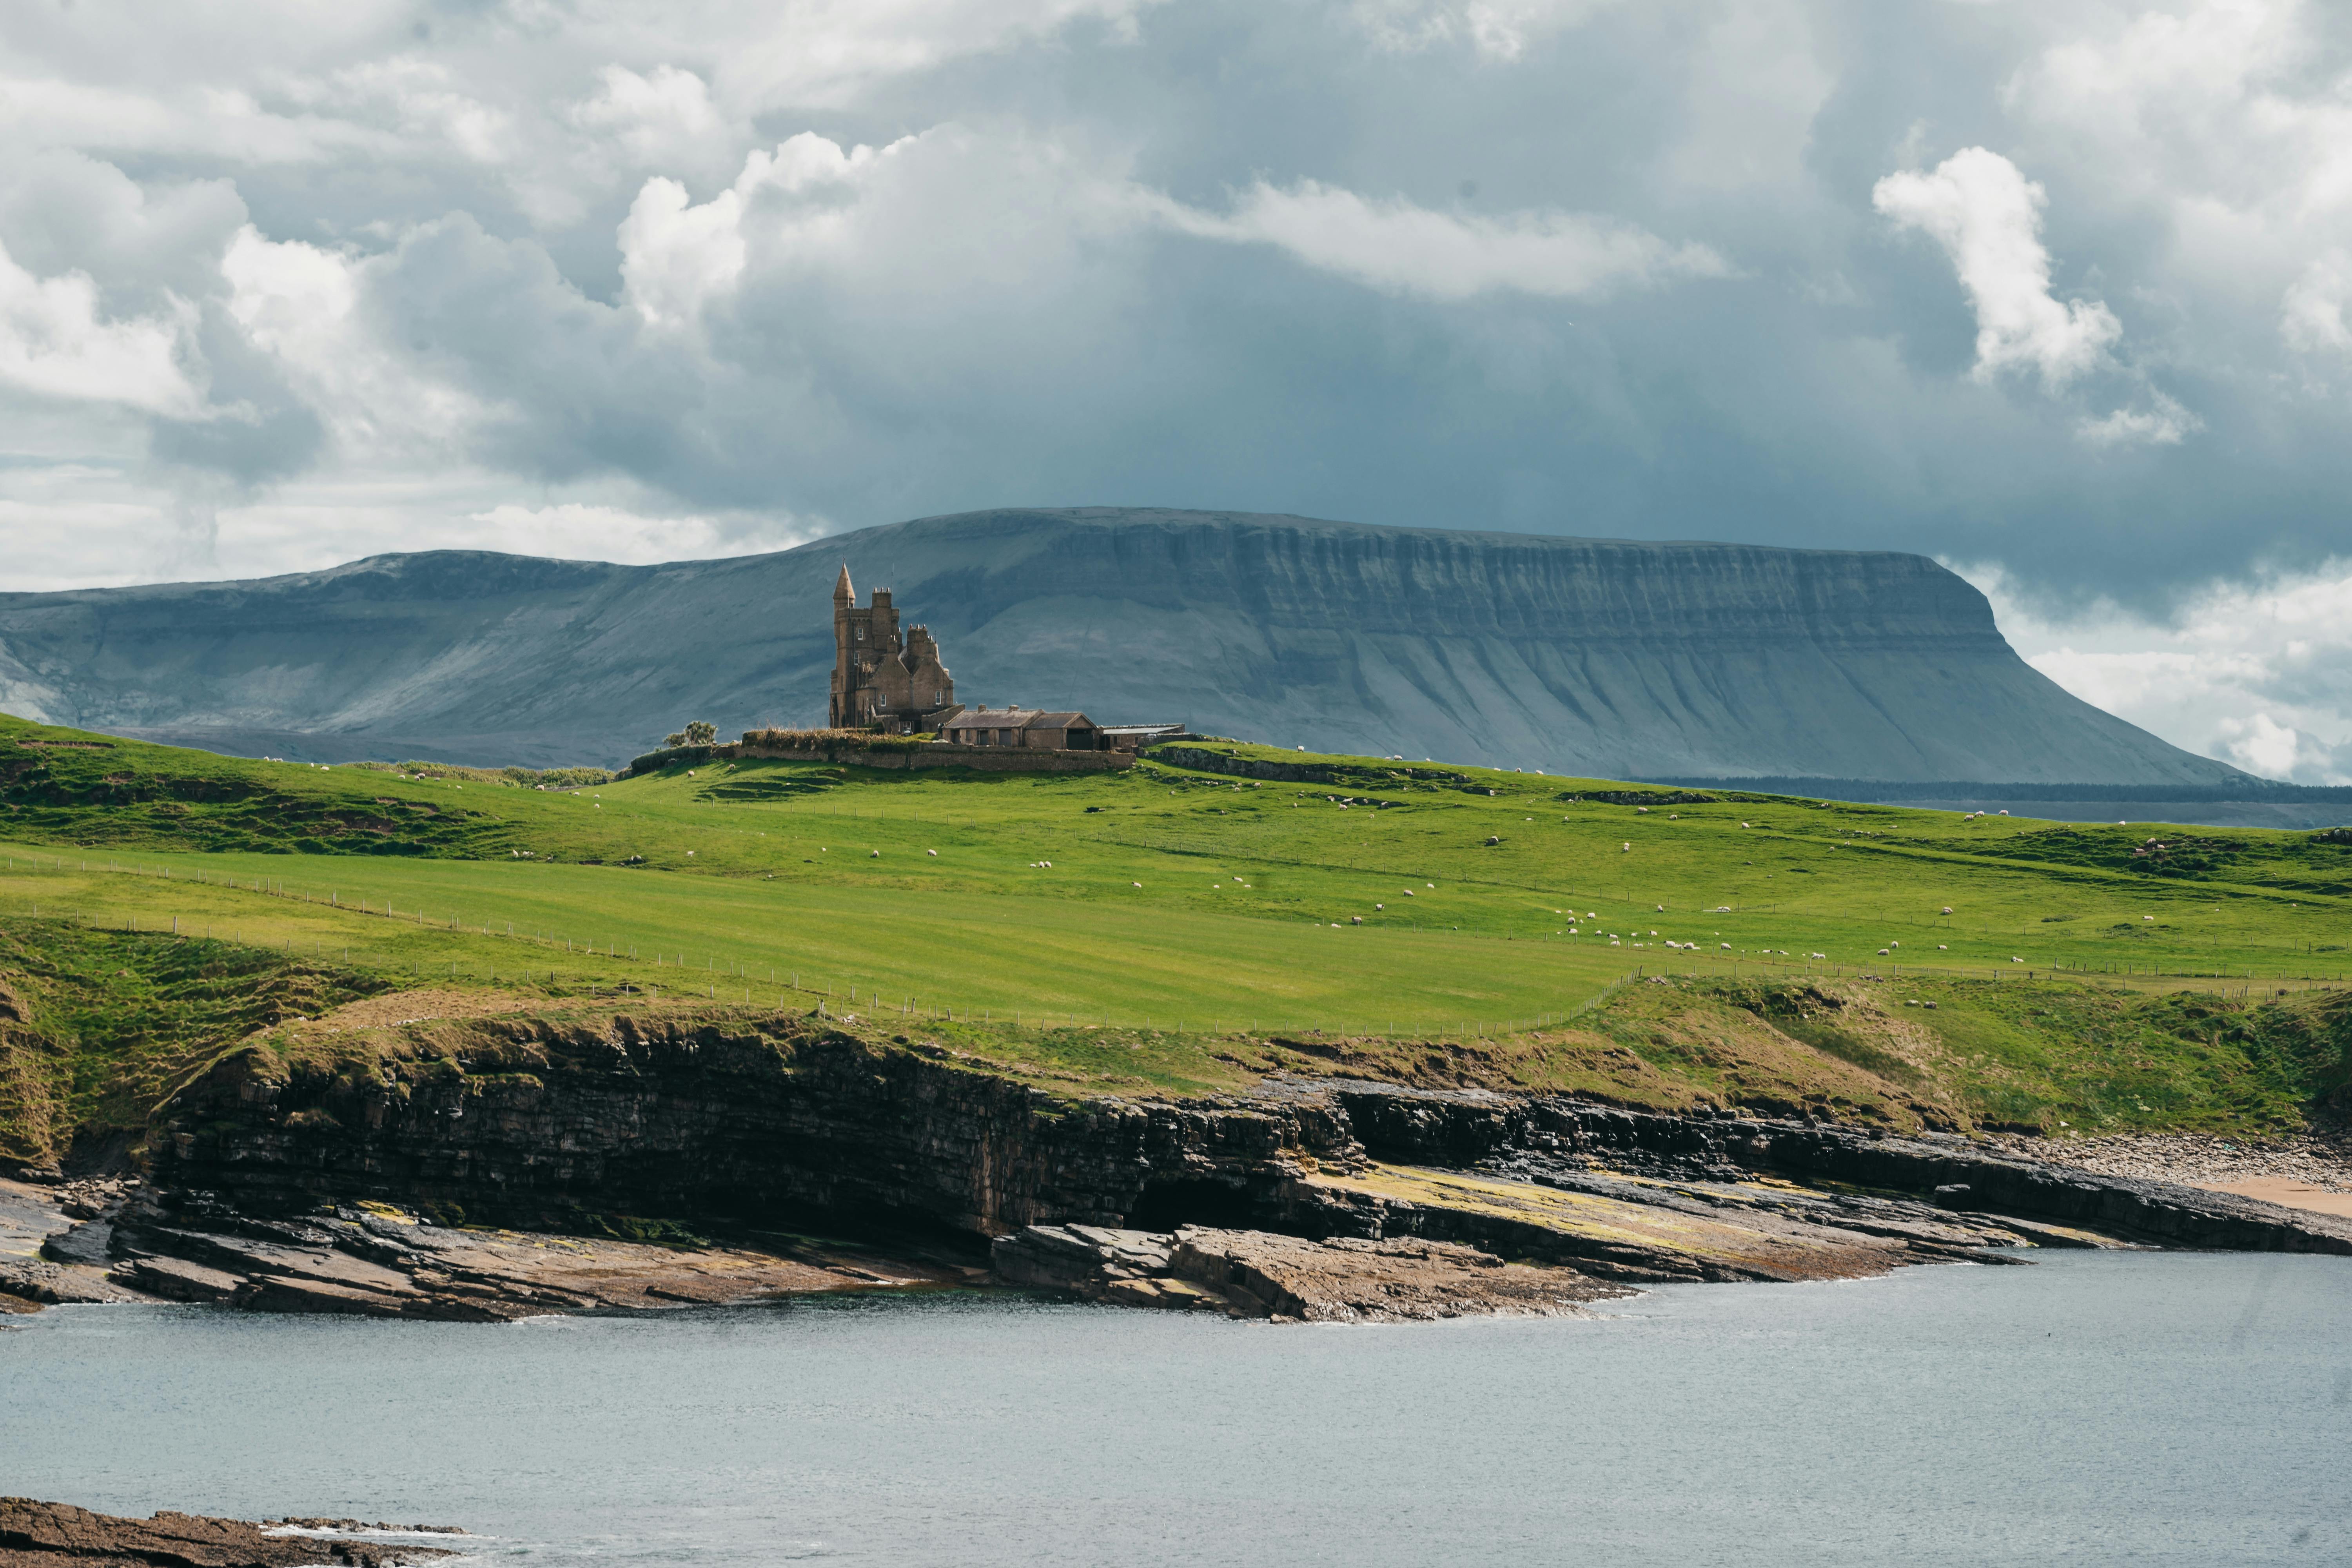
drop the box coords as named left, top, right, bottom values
left=0, top=0, right=2352, bottom=783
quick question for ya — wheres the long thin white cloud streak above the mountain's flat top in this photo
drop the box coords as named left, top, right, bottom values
left=1162, top=179, right=1731, bottom=301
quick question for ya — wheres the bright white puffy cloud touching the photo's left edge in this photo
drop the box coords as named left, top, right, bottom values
left=0, top=236, right=205, bottom=418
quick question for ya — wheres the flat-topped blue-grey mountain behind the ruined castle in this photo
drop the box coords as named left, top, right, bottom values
left=0, top=508, right=2237, bottom=785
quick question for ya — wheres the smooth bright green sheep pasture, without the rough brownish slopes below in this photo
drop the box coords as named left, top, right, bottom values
left=0, top=719, right=2352, bottom=1030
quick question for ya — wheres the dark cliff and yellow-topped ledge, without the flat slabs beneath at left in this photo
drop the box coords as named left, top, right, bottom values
left=142, top=1013, right=2352, bottom=1283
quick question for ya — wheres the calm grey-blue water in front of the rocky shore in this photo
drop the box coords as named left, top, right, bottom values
left=0, top=1253, right=2352, bottom=1568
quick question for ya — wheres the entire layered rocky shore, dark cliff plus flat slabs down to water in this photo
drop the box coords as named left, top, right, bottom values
left=0, top=1013, right=2352, bottom=1319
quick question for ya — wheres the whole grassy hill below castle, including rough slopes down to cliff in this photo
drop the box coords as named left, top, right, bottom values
left=0, top=719, right=2352, bottom=1152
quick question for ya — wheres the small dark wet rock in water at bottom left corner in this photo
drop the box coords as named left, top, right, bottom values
left=0, top=1497, right=452, bottom=1568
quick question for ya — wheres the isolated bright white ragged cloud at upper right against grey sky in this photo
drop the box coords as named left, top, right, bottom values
left=1870, top=148, right=2124, bottom=388
